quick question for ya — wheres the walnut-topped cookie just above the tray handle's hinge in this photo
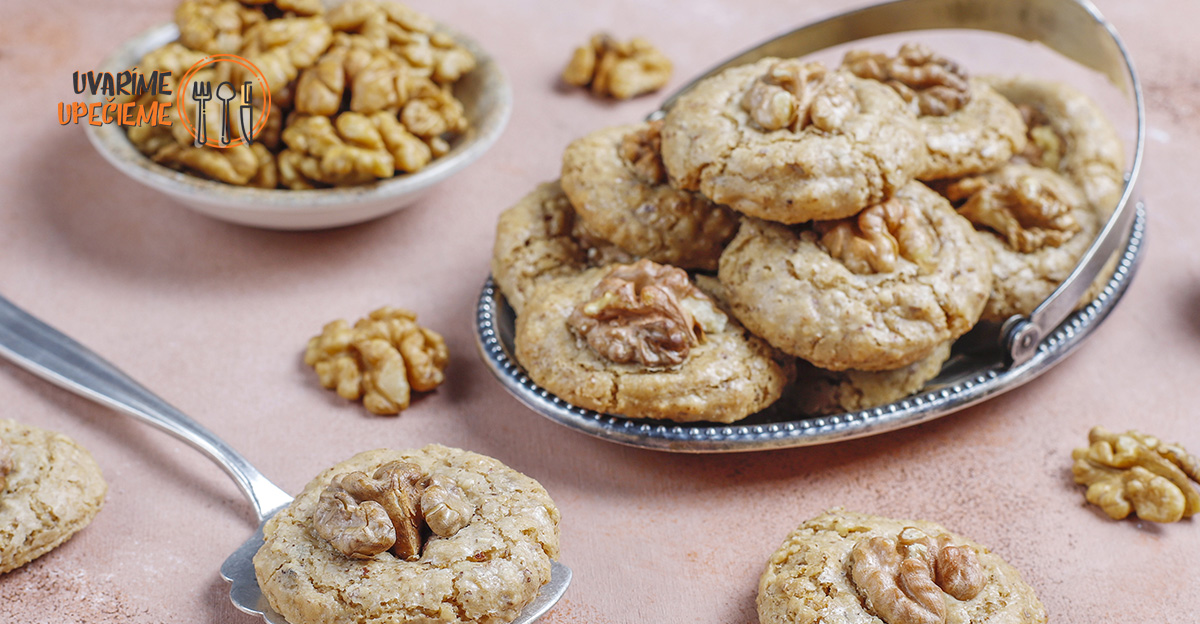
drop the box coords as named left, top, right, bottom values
left=942, top=163, right=1109, bottom=322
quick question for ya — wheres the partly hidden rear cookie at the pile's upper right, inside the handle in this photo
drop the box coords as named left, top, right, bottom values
left=985, top=76, right=1124, bottom=218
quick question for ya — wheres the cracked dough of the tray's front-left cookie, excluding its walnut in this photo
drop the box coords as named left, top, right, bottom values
left=516, top=269, right=791, bottom=422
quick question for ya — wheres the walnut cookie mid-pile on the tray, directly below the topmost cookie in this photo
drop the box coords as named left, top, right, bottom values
left=718, top=182, right=991, bottom=371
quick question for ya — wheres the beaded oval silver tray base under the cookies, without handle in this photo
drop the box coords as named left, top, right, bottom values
left=475, top=202, right=1146, bottom=452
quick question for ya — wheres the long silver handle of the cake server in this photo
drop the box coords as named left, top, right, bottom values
left=0, top=296, right=292, bottom=522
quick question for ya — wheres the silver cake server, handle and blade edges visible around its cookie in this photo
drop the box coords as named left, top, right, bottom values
left=0, top=296, right=571, bottom=624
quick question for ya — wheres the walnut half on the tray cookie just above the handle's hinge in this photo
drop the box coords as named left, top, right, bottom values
left=944, top=166, right=1084, bottom=253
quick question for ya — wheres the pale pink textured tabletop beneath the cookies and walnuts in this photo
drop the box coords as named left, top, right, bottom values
left=0, top=0, right=1200, bottom=624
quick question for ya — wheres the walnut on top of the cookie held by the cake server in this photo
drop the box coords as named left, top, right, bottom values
left=313, top=461, right=475, bottom=562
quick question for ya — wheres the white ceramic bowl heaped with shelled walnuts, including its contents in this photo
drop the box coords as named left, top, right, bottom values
left=86, top=0, right=512, bottom=229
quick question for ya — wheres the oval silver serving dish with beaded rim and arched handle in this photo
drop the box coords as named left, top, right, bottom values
left=475, top=0, right=1146, bottom=452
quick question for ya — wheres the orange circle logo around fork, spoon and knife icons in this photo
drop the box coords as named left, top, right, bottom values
left=175, top=54, right=271, bottom=149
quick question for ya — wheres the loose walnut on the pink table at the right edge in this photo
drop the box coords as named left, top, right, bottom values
left=1070, top=427, right=1200, bottom=522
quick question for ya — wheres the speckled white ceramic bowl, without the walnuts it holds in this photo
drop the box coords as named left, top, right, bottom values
left=86, top=24, right=512, bottom=229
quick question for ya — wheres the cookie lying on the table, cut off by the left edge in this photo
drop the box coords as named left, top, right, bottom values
left=0, top=420, right=108, bottom=574
